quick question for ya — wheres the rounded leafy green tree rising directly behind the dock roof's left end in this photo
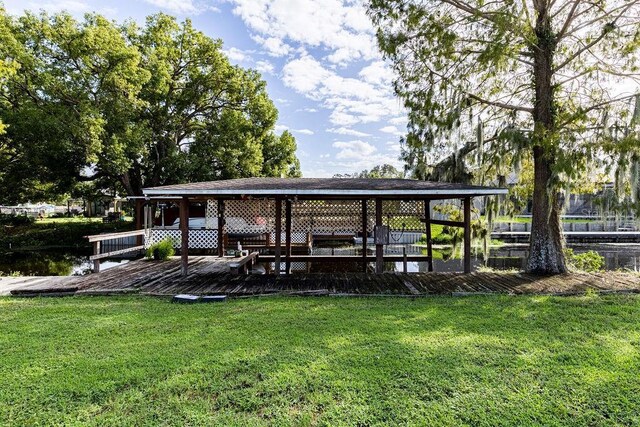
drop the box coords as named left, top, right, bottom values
left=117, top=14, right=297, bottom=194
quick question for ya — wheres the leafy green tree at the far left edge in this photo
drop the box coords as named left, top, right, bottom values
left=0, top=9, right=149, bottom=201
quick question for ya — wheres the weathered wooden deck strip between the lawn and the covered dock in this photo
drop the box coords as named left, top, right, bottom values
left=0, top=256, right=640, bottom=297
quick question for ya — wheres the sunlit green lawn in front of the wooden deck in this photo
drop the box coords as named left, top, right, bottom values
left=0, top=295, right=640, bottom=426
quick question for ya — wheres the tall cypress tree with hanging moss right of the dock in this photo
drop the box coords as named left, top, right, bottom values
left=369, top=0, right=640, bottom=273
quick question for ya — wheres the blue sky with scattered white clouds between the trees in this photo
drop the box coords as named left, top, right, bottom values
left=0, top=0, right=406, bottom=177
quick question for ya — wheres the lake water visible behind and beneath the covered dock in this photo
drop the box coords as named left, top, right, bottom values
left=0, top=243, right=640, bottom=276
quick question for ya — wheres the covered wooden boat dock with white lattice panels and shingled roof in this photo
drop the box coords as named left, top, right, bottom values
left=137, top=178, right=507, bottom=276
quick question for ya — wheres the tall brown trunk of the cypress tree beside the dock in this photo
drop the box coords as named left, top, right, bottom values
left=527, top=1, right=567, bottom=274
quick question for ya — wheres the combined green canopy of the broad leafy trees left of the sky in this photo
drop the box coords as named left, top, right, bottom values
left=0, top=9, right=300, bottom=202
